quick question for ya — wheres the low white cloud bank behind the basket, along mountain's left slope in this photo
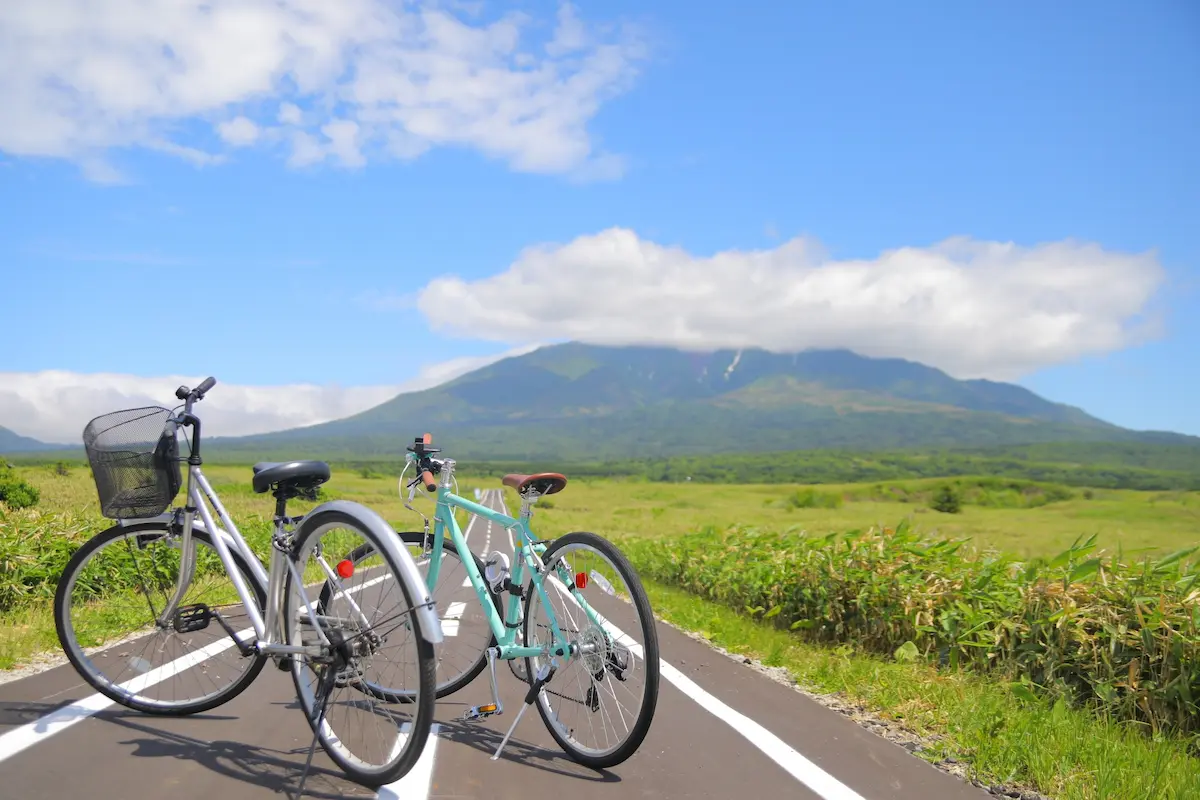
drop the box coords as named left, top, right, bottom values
left=0, top=345, right=535, bottom=444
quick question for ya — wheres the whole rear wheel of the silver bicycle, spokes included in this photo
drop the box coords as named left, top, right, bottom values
left=284, top=510, right=436, bottom=787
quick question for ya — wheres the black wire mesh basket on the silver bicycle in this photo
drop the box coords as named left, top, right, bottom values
left=83, top=407, right=184, bottom=519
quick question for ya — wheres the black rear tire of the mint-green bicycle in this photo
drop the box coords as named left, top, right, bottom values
left=523, top=530, right=660, bottom=769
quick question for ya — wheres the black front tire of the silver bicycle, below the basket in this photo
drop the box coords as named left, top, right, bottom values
left=54, top=521, right=268, bottom=716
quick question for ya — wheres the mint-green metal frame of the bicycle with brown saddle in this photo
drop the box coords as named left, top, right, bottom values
left=415, top=459, right=602, bottom=660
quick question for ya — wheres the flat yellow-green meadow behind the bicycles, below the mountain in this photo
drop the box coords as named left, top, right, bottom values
left=17, top=465, right=1200, bottom=555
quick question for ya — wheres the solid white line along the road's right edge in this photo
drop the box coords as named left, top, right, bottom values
left=494, top=494, right=864, bottom=800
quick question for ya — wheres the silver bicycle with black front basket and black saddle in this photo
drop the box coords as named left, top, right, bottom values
left=54, top=378, right=442, bottom=787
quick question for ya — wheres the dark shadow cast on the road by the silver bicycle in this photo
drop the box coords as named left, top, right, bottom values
left=3, top=704, right=376, bottom=800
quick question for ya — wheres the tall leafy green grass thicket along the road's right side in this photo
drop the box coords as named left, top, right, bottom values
left=623, top=524, right=1200, bottom=734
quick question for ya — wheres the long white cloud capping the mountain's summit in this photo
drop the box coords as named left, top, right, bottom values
left=418, top=228, right=1164, bottom=380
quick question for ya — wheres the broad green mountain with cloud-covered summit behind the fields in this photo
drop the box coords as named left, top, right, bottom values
left=206, top=343, right=1200, bottom=462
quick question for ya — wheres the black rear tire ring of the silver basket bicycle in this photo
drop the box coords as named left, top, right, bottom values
left=283, top=510, right=437, bottom=787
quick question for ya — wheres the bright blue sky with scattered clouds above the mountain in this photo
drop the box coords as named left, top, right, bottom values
left=0, top=0, right=1200, bottom=438
